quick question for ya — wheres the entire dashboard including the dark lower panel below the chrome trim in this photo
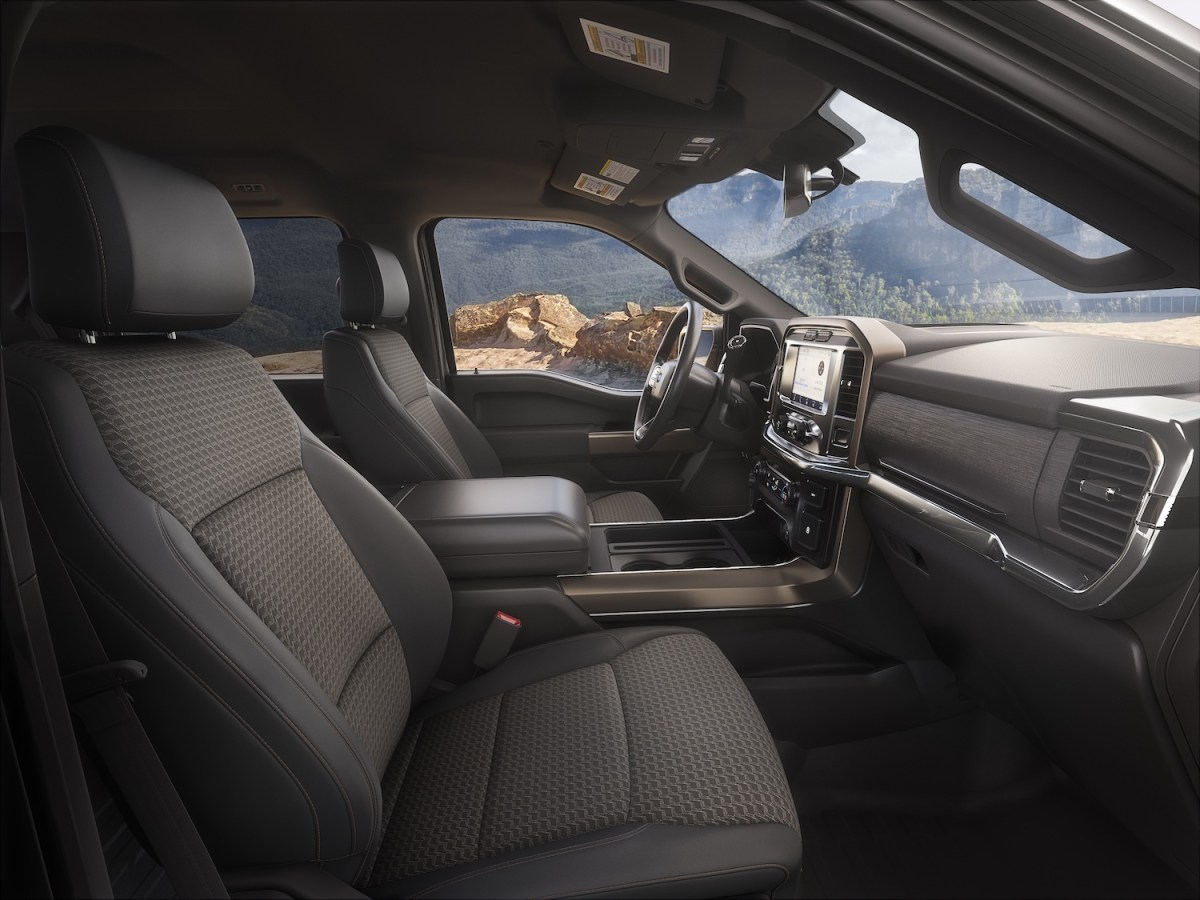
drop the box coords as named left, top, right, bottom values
left=743, top=318, right=1200, bottom=883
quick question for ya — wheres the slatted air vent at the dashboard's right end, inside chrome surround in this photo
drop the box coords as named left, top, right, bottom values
left=1058, top=438, right=1150, bottom=563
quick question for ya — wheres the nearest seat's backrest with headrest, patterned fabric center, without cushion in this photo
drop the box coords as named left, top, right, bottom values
left=5, top=128, right=450, bottom=880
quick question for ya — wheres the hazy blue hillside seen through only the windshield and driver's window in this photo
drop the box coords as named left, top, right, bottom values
left=436, top=169, right=1152, bottom=322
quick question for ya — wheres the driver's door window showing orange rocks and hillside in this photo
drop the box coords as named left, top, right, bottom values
left=433, top=218, right=683, bottom=390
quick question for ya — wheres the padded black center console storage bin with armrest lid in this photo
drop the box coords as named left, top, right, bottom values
left=392, top=478, right=589, bottom=578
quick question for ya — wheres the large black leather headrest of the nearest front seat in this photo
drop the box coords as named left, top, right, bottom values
left=17, top=127, right=254, bottom=332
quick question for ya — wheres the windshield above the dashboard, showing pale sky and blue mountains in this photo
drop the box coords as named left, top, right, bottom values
left=667, top=94, right=1200, bottom=344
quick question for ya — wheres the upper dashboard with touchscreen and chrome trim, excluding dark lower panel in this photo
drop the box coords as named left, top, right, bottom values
left=751, top=318, right=1200, bottom=614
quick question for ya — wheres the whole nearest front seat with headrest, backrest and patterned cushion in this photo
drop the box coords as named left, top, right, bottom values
left=5, top=127, right=800, bottom=898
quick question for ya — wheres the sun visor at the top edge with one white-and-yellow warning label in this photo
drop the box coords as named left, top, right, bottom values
left=554, top=2, right=725, bottom=109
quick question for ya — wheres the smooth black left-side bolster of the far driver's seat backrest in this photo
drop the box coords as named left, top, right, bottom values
left=323, top=331, right=461, bottom=486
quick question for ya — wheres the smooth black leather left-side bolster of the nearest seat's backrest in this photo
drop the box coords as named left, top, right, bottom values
left=5, top=346, right=382, bottom=880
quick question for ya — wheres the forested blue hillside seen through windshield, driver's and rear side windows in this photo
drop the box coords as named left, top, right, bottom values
left=201, top=176, right=1200, bottom=355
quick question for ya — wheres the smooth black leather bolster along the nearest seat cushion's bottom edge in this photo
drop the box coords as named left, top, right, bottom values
left=370, top=824, right=800, bottom=900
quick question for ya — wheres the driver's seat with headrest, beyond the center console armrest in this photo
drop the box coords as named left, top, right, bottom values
left=323, top=239, right=662, bottom=522
